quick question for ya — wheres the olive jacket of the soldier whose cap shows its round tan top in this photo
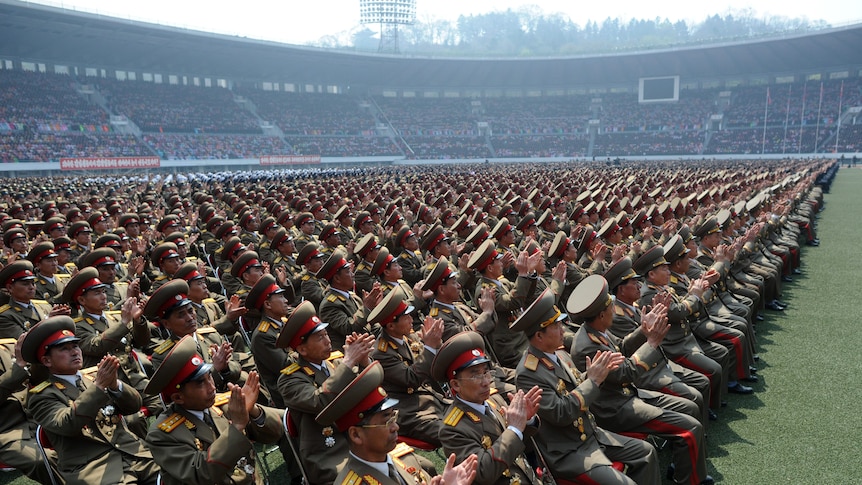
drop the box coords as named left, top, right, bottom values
left=572, top=325, right=663, bottom=429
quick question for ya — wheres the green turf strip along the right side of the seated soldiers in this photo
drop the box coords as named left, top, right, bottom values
left=5, top=169, right=862, bottom=485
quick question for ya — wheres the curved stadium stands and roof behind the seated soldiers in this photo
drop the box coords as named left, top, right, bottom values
left=0, top=1, right=862, bottom=172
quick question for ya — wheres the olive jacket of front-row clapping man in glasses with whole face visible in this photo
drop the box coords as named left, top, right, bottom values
left=440, top=399, right=541, bottom=485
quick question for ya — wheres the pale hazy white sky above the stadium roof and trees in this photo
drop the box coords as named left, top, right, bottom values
left=27, top=0, right=862, bottom=44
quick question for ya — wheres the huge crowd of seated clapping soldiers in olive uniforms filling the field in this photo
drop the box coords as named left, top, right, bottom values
left=0, top=160, right=835, bottom=485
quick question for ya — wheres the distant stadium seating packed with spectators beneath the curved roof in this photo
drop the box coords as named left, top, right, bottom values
left=0, top=70, right=862, bottom=162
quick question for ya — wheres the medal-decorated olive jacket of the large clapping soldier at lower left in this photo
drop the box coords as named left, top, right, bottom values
left=28, top=375, right=152, bottom=485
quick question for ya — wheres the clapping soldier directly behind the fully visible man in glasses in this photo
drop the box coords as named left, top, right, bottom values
left=368, top=288, right=449, bottom=446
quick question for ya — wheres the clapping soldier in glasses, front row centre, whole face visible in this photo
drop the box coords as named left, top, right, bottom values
left=431, top=331, right=542, bottom=485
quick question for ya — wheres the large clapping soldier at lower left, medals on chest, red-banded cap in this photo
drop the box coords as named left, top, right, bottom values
left=21, top=316, right=159, bottom=485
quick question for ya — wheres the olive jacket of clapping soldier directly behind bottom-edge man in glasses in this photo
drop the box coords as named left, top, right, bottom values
left=278, top=352, right=356, bottom=485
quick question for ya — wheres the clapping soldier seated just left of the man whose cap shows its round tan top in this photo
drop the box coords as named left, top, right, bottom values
left=512, top=292, right=661, bottom=484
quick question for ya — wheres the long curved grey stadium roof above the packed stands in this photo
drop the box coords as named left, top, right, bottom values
left=0, top=0, right=862, bottom=90
